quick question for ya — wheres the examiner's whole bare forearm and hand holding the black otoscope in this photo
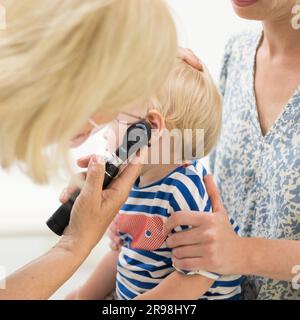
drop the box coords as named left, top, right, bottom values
left=0, top=156, right=141, bottom=299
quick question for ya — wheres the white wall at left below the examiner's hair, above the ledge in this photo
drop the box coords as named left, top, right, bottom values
left=0, top=134, right=104, bottom=234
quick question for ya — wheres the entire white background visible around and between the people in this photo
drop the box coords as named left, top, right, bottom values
left=0, top=0, right=256, bottom=298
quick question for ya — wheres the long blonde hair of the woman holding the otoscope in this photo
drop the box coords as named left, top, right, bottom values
left=0, top=0, right=177, bottom=183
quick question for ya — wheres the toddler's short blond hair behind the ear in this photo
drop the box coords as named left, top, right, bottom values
left=147, top=60, right=222, bottom=160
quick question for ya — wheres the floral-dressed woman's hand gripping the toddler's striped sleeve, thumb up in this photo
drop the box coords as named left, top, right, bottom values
left=164, top=175, right=247, bottom=275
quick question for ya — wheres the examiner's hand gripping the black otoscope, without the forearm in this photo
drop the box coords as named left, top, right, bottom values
left=60, top=156, right=141, bottom=255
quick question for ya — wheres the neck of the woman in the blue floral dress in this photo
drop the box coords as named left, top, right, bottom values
left=262, top=12, right=300, bottom=57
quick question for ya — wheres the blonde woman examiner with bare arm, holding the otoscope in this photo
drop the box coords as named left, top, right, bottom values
left=0, top=0, right=188, bottom=299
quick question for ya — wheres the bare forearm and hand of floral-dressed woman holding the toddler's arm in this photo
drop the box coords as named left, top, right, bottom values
left=165, top=176, right=300, bottom=281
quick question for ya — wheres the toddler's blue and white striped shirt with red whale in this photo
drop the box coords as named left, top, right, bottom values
left=116, top=161, right=241, bottom=300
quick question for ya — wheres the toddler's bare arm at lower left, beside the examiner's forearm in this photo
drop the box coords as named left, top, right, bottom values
left=66, top=251, right=119, bottom=300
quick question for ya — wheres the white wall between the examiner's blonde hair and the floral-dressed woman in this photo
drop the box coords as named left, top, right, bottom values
left=168, top=0, right=257, bottom=79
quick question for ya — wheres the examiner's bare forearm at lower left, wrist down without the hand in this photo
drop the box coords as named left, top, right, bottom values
left=0, top=237, right=90, bottom=300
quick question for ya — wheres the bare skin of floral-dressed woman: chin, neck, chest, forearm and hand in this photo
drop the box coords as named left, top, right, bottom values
left=110, top=0, right=300, bottom=281
